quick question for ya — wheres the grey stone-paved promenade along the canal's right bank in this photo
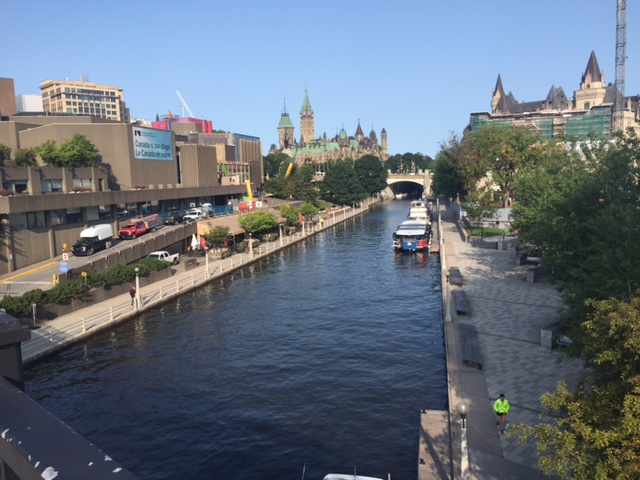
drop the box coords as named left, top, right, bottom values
left=441, top=207, right=584, bottom=480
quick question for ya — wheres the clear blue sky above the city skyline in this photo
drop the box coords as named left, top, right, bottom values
left=0, top=0, right=640, bottom=156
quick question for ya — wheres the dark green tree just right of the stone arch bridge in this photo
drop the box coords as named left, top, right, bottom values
left=431, top=133, right=467, bottom=198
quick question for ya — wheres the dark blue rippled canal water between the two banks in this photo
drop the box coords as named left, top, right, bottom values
left=26, top=201, right=447, bottom=480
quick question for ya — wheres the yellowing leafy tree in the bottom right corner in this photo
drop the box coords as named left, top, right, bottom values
left=514, top=296, right=640, bottom=480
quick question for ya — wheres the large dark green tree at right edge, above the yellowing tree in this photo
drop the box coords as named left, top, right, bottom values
left=512, top=135, right=640, bottom=330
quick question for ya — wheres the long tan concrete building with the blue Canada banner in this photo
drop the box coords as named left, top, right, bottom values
left=0, top=113, right=262, bottom=274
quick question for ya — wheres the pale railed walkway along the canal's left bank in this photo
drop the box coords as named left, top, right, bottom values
left=22, top=201, right=373, bottom=363
